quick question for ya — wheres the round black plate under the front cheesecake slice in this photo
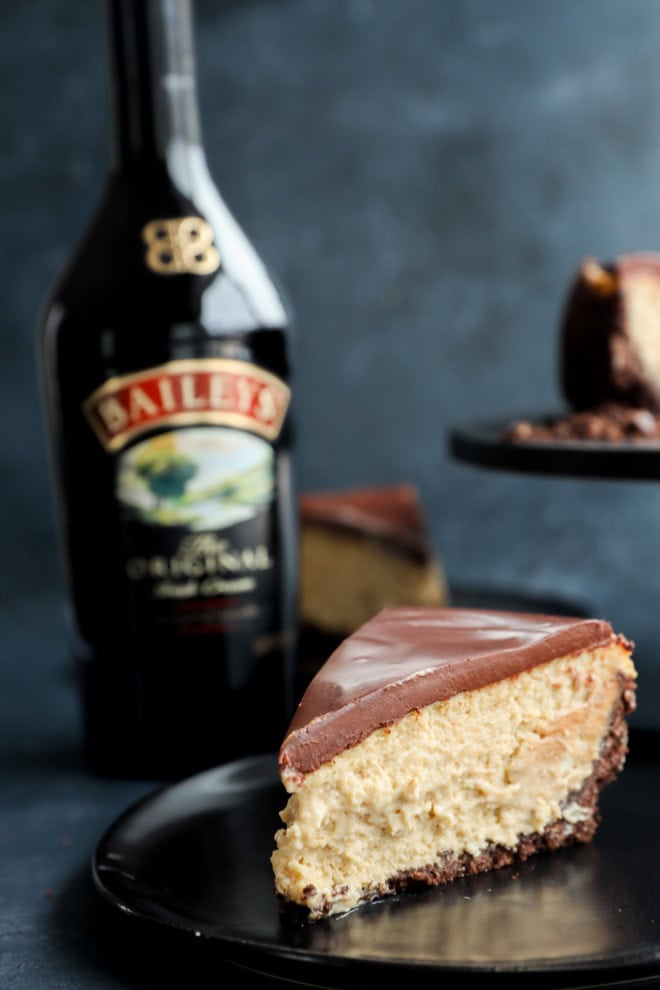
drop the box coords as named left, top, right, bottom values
left=93, top=743, right=660, bottom=988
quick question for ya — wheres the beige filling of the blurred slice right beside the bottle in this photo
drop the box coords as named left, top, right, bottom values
left=300, top=525, right=447, bottom=635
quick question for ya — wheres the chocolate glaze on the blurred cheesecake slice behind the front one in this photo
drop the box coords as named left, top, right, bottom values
left=300, top=482, right=431, bottom=560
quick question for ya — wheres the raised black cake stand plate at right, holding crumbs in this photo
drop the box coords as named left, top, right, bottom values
left=449, top=413, right=660, bottom=481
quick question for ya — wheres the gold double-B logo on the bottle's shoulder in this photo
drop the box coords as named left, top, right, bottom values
left=142, top=217, right=220, bottom=275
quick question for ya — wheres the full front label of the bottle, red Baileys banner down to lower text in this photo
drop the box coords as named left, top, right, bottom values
left=84, top=359, right=289, bottom=637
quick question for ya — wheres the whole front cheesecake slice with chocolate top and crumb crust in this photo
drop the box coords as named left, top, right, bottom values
left=271, top=607, right=636, bottom=921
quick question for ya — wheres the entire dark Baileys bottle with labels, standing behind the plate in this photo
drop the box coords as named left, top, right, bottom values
left=38, top=0, right=297, bottom=779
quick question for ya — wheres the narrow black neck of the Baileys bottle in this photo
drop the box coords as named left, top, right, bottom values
left=106, top=0, right=203, bottom=171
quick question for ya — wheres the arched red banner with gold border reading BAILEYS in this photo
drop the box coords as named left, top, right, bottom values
left=83, top=358, right=291, bottom=450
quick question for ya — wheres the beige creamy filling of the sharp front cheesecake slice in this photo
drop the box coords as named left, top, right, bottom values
left=272, top=645, right=634, bottom=913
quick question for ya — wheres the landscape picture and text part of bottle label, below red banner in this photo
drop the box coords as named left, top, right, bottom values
left=116, top=426, right=275, bottom=634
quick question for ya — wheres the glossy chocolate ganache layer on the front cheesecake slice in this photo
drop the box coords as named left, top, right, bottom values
left=279, top=606, right=621, bottom=774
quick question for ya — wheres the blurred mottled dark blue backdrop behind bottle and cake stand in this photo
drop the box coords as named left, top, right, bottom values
left=0, top=0, right=660, bottom=987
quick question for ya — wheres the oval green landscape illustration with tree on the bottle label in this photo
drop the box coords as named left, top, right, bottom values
left=117, top=427, right=274, bottom=530
